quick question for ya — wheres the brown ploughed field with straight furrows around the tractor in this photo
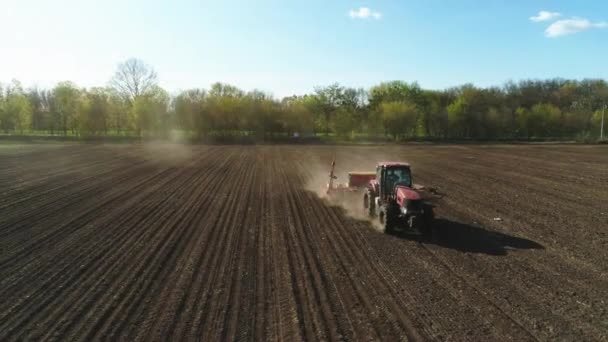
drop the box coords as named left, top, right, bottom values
left=0, top=144, right=608, bottom=341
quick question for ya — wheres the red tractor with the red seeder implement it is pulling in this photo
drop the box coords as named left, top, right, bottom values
left=327, top=162, right=436, bottom=238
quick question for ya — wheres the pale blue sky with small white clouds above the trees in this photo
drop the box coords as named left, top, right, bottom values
left=0, top=0, right=608, bottom=96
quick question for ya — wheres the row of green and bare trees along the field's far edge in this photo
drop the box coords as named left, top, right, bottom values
left=0, top=59, right=608, bottom=141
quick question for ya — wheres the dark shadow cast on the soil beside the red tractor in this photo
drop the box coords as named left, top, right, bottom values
left=418, top=218, right=544, bottom=255
